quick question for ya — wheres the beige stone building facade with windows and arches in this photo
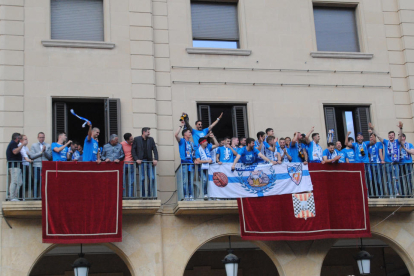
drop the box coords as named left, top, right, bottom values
left=0, top=0, right=414, bottom=276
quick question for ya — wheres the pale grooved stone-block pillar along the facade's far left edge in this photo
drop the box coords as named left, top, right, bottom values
left=0, top=0, right=24, bottom=200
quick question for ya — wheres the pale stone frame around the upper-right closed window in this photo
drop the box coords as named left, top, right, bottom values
left=310, top=0, right=372, bottom=54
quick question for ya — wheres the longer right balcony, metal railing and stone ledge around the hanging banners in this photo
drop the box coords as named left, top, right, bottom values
left=174, top=164, right=414, bottom=215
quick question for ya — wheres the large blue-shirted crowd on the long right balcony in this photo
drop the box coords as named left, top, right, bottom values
left=175, top=113, right=414, bottom=200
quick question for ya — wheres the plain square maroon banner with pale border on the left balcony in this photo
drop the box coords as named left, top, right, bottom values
left=42, top=162, right=123, bottom=243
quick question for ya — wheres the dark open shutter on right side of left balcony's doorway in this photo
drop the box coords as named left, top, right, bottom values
left=105, top=99, right=122, bottom=142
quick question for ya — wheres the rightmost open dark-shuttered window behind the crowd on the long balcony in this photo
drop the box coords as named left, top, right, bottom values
left=324, top=106, right=371, bottom=143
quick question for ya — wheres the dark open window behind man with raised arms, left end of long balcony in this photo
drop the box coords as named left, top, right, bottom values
left=198, top=104, right=249, bottom=138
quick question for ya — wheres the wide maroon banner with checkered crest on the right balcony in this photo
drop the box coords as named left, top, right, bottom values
left=237, top=164, right=371, bottom=241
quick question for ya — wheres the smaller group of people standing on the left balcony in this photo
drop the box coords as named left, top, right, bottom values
left=6, top=122, right=158, bottom=201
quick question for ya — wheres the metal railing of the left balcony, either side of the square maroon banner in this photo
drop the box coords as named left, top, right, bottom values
left=6, top=161, right=157, bottom=201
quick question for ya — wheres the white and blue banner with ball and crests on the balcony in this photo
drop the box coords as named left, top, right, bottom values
left=208, top=163, right=313, bottom=198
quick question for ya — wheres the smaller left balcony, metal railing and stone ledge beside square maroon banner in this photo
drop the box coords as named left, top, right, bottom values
left=2, top=162, right=161, bottom=217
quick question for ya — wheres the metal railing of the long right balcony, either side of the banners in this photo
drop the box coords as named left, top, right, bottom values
left=175, top=164, right=413, bottom=201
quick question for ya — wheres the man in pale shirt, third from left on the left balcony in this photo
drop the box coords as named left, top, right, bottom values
left=29, top=132, right=52, bottom=198
